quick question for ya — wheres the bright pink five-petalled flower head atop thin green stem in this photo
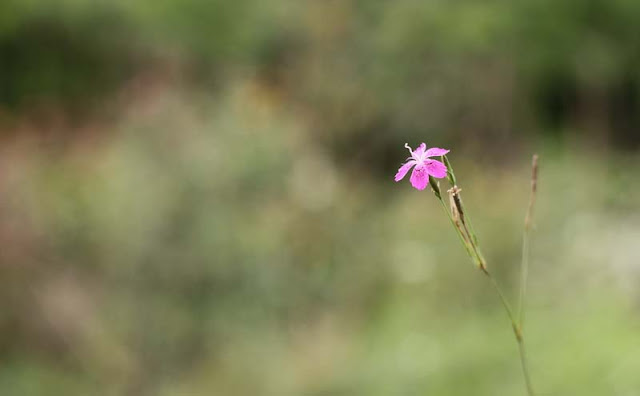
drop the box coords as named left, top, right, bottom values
left=396, top=143, right=449, bottom=190
